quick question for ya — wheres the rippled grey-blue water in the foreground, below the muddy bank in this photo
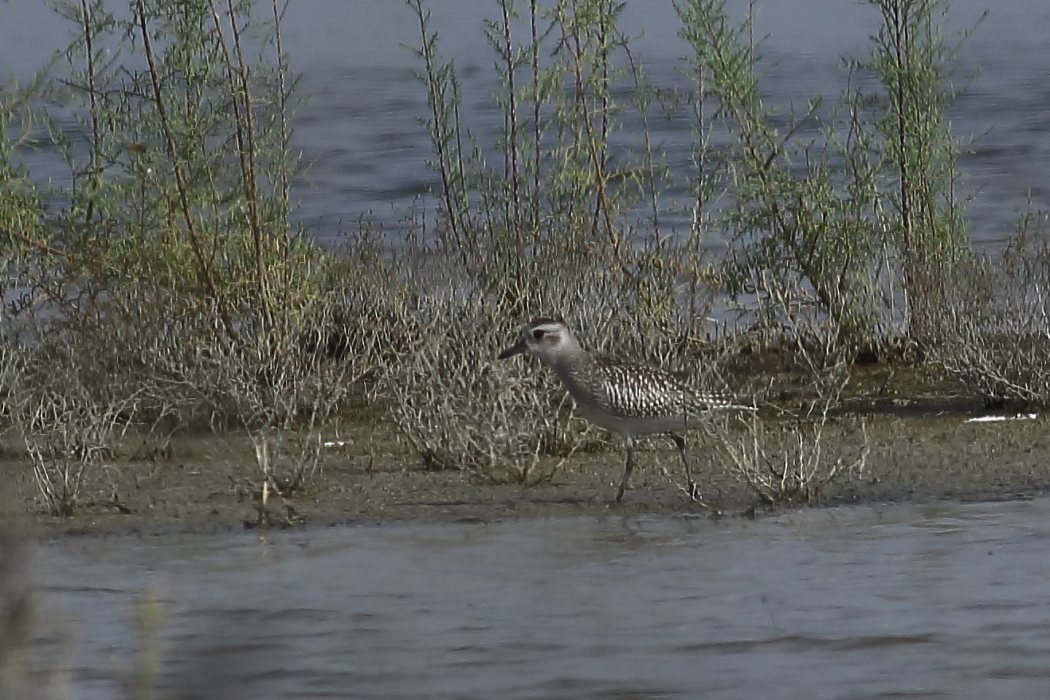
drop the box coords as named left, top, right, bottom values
left=36, top=500, right=1050, bottom=700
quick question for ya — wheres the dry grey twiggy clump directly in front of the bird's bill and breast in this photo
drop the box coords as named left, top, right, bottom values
left=386, top=297, right=589, bottom=484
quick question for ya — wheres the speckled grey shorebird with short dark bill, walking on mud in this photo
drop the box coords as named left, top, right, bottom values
left=499, top=318, right=755, bottom=503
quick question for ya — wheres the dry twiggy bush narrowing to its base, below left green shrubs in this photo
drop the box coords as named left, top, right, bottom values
left=171, top=292, right=387, bottom=495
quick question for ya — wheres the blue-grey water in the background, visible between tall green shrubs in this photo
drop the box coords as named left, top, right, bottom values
left=0, top=0, right=1050, bottom=242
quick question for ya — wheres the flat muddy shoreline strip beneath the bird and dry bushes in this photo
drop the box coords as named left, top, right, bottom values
left=0, top=402, right=1050, bottom=537
